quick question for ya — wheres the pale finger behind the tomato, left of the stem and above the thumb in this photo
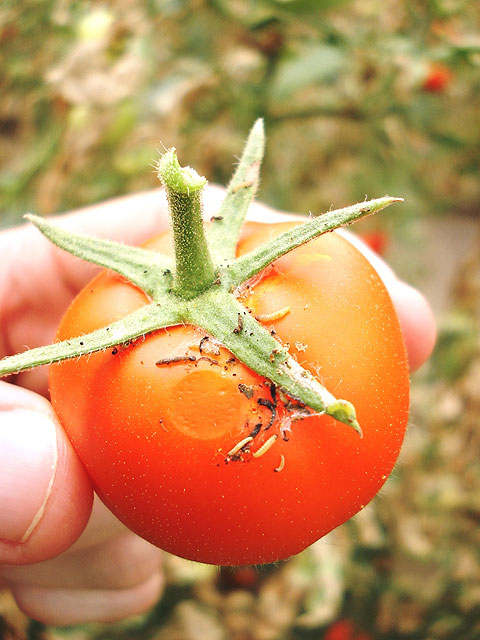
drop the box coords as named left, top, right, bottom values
left=0, top=191, right=168, bottom=394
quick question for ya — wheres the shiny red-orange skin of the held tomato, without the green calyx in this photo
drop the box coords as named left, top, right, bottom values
left=50, top=223, right=408, bottom=565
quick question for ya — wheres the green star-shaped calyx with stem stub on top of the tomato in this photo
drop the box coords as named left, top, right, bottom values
left=0, top=120, right=401, bottom=434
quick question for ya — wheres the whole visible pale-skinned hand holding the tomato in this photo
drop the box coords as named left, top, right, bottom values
left=0, top=187, right=435, bottom=625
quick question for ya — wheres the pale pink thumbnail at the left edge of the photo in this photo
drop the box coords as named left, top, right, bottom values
left=0, top=408, right=57, bottom=543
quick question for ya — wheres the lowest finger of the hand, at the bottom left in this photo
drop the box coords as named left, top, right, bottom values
left=12, top=572, right=164, bottom=626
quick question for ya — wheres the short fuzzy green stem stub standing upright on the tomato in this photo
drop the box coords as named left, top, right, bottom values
left=158, top=149, right=215, bottom=300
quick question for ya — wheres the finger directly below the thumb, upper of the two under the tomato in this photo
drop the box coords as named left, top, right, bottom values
left=0, top=530, right=162, bottom=590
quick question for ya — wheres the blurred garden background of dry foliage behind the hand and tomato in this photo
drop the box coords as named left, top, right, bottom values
left=0, top=0, right=480, bottom=640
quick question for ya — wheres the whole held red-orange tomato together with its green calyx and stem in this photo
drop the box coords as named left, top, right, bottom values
left=1, top=120, right=408, bottom=565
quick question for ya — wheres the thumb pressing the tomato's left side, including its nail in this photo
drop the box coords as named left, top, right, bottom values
left=0, top=382, right=93, bottom=564
